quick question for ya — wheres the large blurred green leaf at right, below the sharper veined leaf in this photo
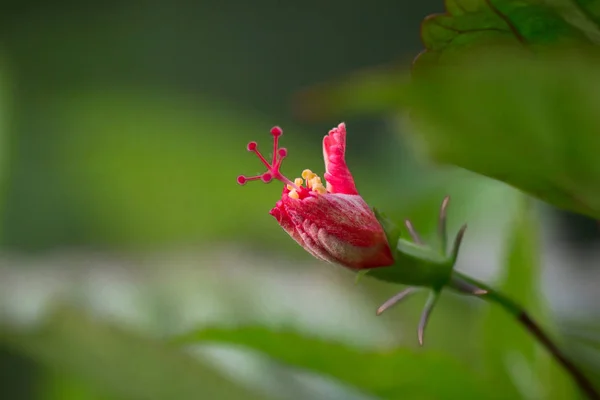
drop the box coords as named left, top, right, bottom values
left=411, top=48, right=600, bottom=222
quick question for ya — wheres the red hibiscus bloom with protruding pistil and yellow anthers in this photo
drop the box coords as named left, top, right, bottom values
left=237, top=123, right=394, bottom=270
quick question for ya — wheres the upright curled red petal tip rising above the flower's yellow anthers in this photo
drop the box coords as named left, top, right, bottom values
left=323, top=123, right=358, bottom=194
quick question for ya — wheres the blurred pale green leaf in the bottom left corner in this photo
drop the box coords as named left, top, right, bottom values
left=0, top=308, right=265, bottom=400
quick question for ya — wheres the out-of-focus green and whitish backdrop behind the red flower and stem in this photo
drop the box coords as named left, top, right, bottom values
left=0, top=0, right=600, bottom=400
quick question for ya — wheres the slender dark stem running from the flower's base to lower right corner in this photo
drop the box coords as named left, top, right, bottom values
left=454, top=271, right=600, bottom=400
